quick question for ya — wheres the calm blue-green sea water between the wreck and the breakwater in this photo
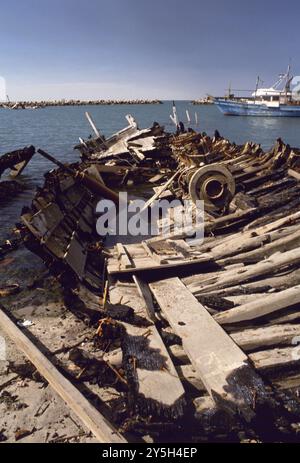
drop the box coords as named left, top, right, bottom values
left=0, top=101, right=300, bottom=239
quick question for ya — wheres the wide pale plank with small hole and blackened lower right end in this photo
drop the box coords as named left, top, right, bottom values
left=150, top=278, right=264, bottom=419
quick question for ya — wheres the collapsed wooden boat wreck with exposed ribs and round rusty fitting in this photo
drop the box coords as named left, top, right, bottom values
left=2, top=124, right=300, bottom=442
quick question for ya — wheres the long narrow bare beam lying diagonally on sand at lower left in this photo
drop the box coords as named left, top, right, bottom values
left=0, top=308, right=127, bottom=443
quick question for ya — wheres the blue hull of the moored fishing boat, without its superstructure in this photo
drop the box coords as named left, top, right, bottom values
left=215, top=100, right=300, bottom=117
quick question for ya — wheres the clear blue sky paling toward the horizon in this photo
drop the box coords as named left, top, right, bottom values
left=0, top=0, right=300, bottom=100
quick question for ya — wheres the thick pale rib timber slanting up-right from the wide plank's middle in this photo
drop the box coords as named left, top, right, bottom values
left=214, top=285, right=300, bottom=325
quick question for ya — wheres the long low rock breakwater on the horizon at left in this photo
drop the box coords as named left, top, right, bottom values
left=0, top=99, right=163, bottom=109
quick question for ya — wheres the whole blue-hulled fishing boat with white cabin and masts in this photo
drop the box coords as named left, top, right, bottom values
left=214, top=67, right=300, bottom=117
